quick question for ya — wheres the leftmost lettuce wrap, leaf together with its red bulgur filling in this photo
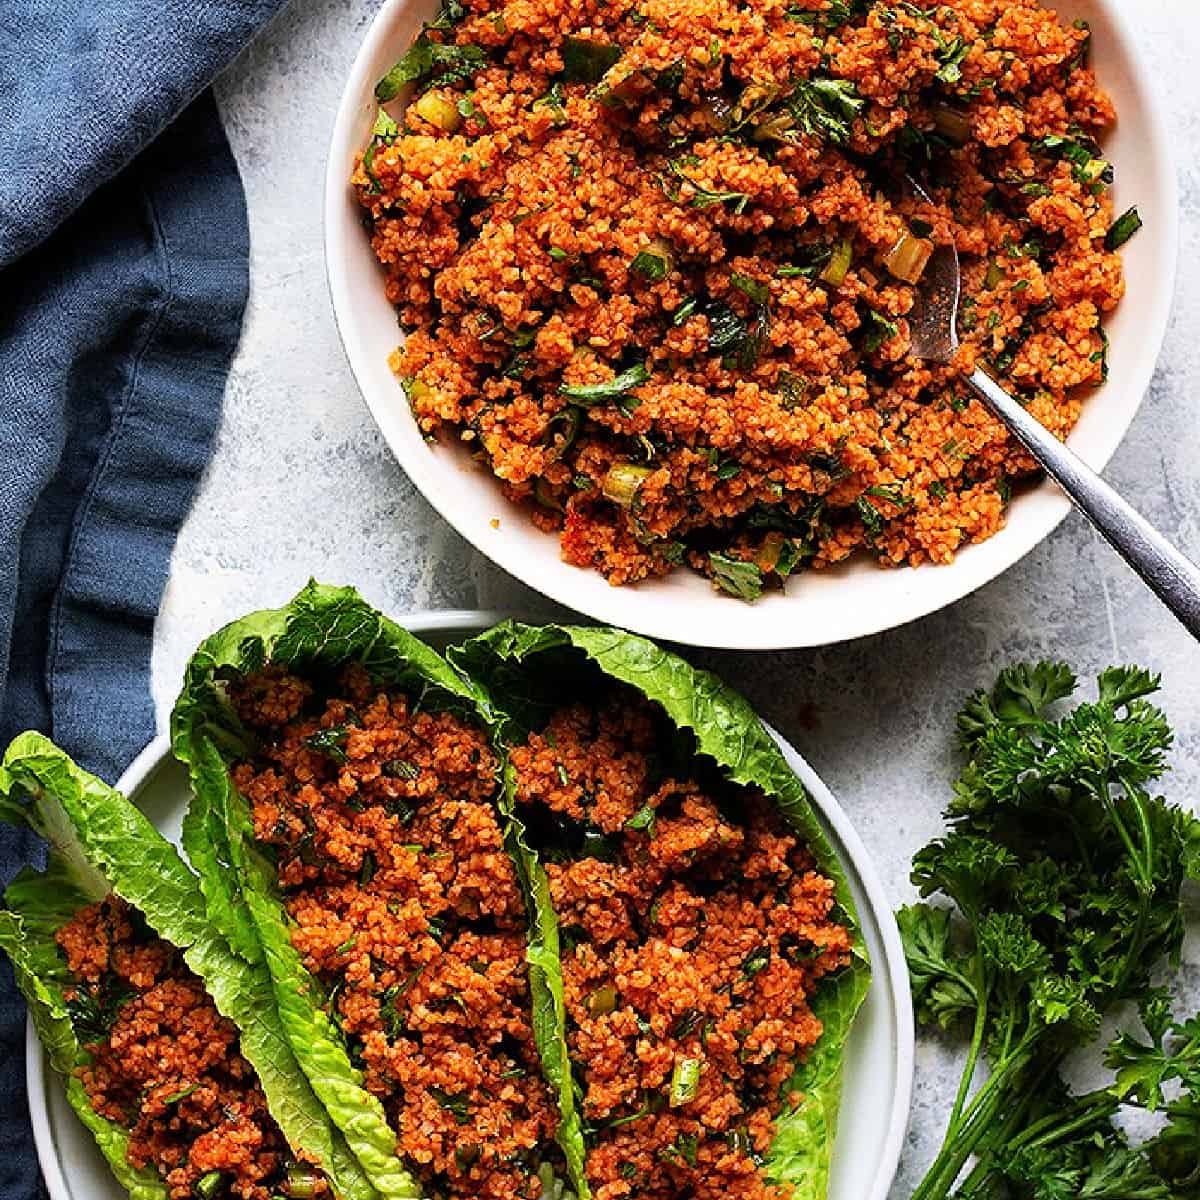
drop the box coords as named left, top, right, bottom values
left=0, top=733, right=377, bottom=1200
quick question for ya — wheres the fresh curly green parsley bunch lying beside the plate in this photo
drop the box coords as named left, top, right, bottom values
left=899, top=662, right=1200, bottom=1200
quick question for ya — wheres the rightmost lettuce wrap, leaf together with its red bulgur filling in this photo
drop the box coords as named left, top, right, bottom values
left=446, top=622, right=870, bottom=1200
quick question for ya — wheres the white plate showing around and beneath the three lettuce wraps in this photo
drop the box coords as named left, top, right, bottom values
left=25, top=612, right=913, bottom=1200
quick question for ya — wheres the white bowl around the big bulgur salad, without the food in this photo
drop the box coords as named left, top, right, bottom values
left=325, top=0, right=1177, bottom=649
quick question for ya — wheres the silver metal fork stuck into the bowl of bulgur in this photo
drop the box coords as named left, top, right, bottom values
left=908, top=179, right=1200, bottom=640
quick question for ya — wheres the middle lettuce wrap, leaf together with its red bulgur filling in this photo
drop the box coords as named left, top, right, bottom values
left=172, top=583, right=582, bottom=1200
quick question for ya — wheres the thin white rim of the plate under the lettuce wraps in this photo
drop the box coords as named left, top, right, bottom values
left=25, top=608, right=916, bottom=1200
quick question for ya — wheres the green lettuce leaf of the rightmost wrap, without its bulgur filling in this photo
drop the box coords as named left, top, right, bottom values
left=448, top=622, right=870, bottom=1200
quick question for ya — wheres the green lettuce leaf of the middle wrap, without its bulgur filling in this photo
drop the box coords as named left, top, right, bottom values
left=172, top=583, right=492, bottom=1200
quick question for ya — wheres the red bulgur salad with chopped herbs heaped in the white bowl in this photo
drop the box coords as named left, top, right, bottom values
left=353, top=0, right=1140, bottom=599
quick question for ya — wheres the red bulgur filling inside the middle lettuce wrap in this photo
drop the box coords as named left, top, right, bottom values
left=233, top=668, right=557, bottom=1200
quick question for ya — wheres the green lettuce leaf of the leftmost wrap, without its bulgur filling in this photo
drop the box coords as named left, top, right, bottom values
left=0, top=733, right=374, bottom=1200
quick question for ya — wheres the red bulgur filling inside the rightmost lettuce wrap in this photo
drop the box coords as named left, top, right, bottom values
left=511, top=691, right=850, bottom=1200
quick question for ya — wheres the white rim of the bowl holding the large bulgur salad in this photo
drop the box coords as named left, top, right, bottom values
left=322, top=0, right=1180, bottom=650
